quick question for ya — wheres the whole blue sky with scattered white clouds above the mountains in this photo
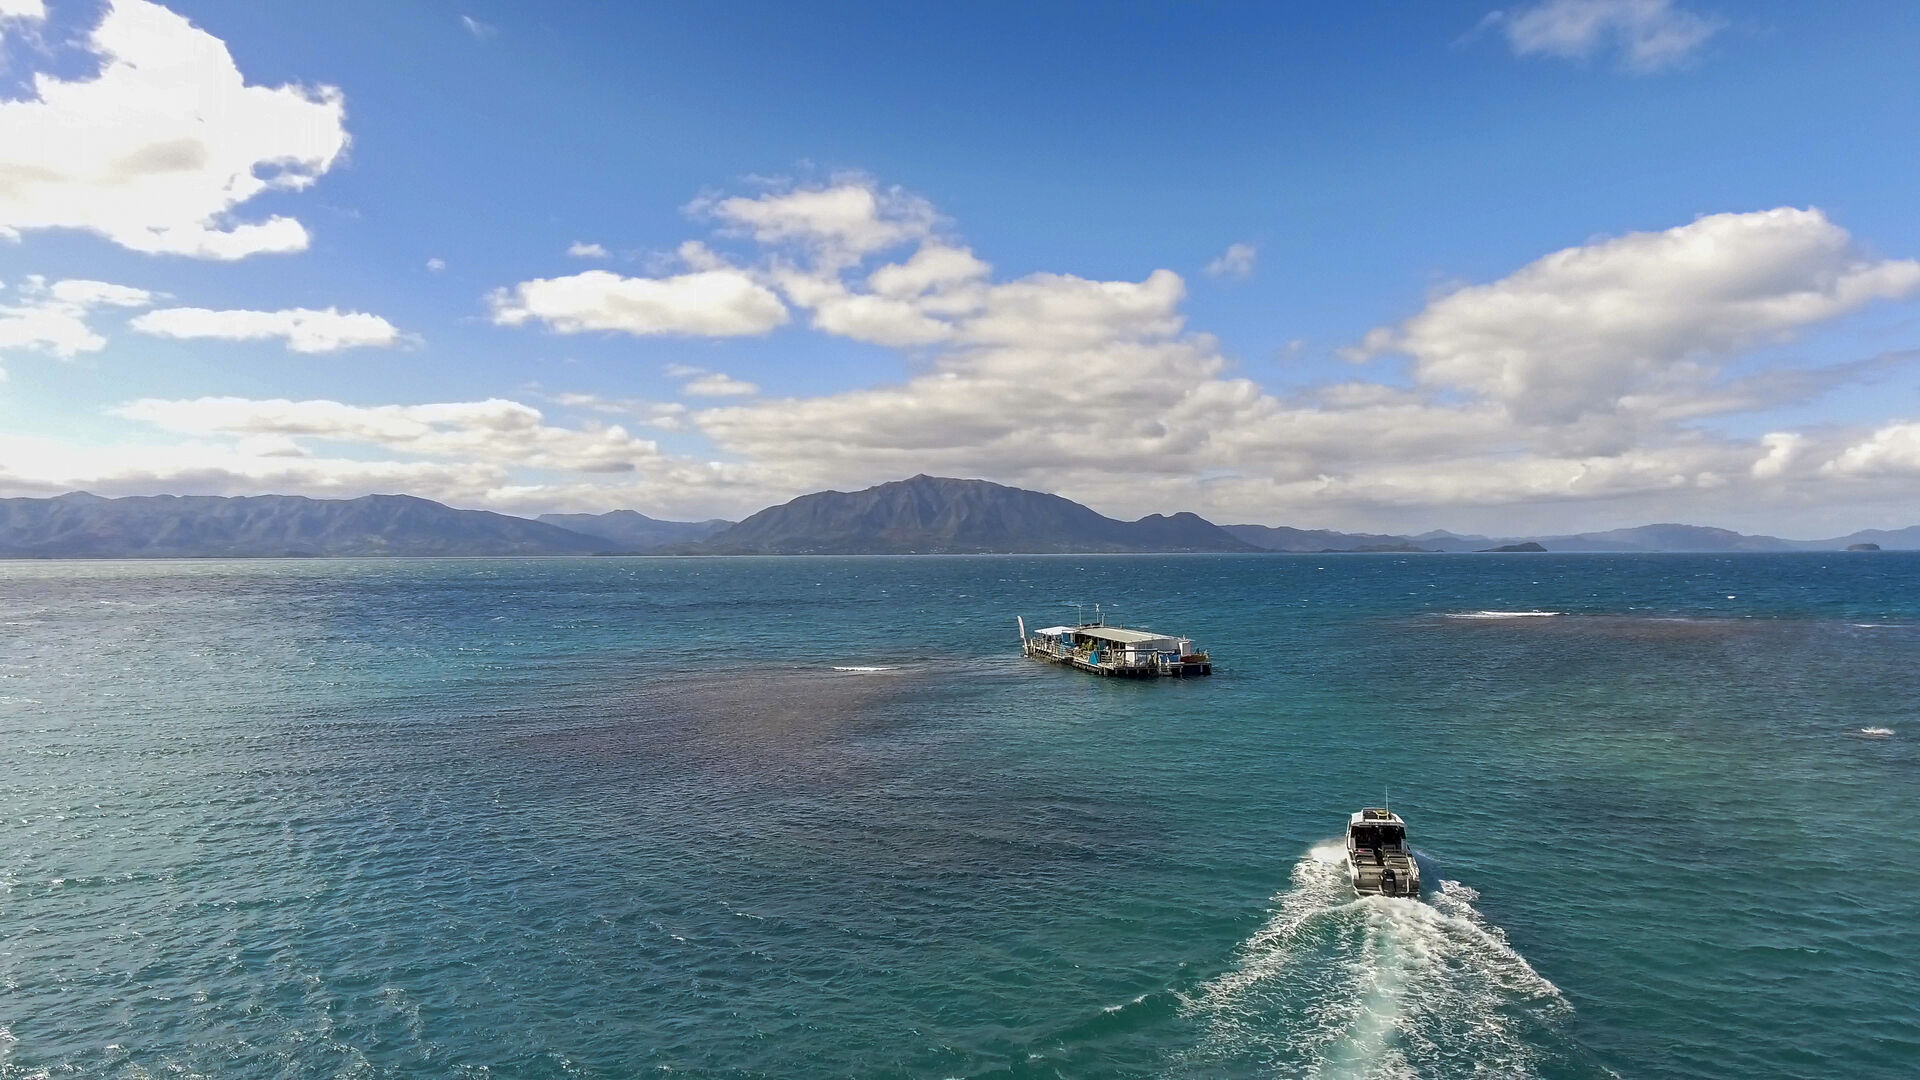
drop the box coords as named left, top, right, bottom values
left=0, top=0, right=1920, bottom=538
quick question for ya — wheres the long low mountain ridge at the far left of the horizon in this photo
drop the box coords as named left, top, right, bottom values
left=0, top=492, right=620, bottom=559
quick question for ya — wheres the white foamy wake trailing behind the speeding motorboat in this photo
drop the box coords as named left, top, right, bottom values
left=1187, top=842, right=1572, bottom=1078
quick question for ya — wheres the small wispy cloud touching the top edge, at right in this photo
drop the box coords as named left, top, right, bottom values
left=1490, top=0, right=1726, bottom=73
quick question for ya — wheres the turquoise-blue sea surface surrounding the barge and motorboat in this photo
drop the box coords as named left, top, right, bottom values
left=0, top=553, right=1920, bottom=1080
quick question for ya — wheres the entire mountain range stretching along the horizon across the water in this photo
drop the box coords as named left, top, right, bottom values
left=0, top=477, right=1920, bottom=559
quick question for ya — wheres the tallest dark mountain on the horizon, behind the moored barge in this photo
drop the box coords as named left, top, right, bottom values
left=689, top=477, right=1256, bottom=555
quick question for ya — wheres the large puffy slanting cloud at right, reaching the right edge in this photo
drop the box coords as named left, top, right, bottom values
left=1363, top=208, right=1920, bottom=423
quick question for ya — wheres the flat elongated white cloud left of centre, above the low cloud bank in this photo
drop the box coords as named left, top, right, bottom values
left=490, top=269, right=787, bottom=336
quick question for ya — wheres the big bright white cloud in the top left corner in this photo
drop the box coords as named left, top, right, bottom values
left=0, top=0, right=348, bottom=259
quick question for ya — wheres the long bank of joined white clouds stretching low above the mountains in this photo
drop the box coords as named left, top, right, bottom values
left=30, top=179, right=1920, bottom=530
